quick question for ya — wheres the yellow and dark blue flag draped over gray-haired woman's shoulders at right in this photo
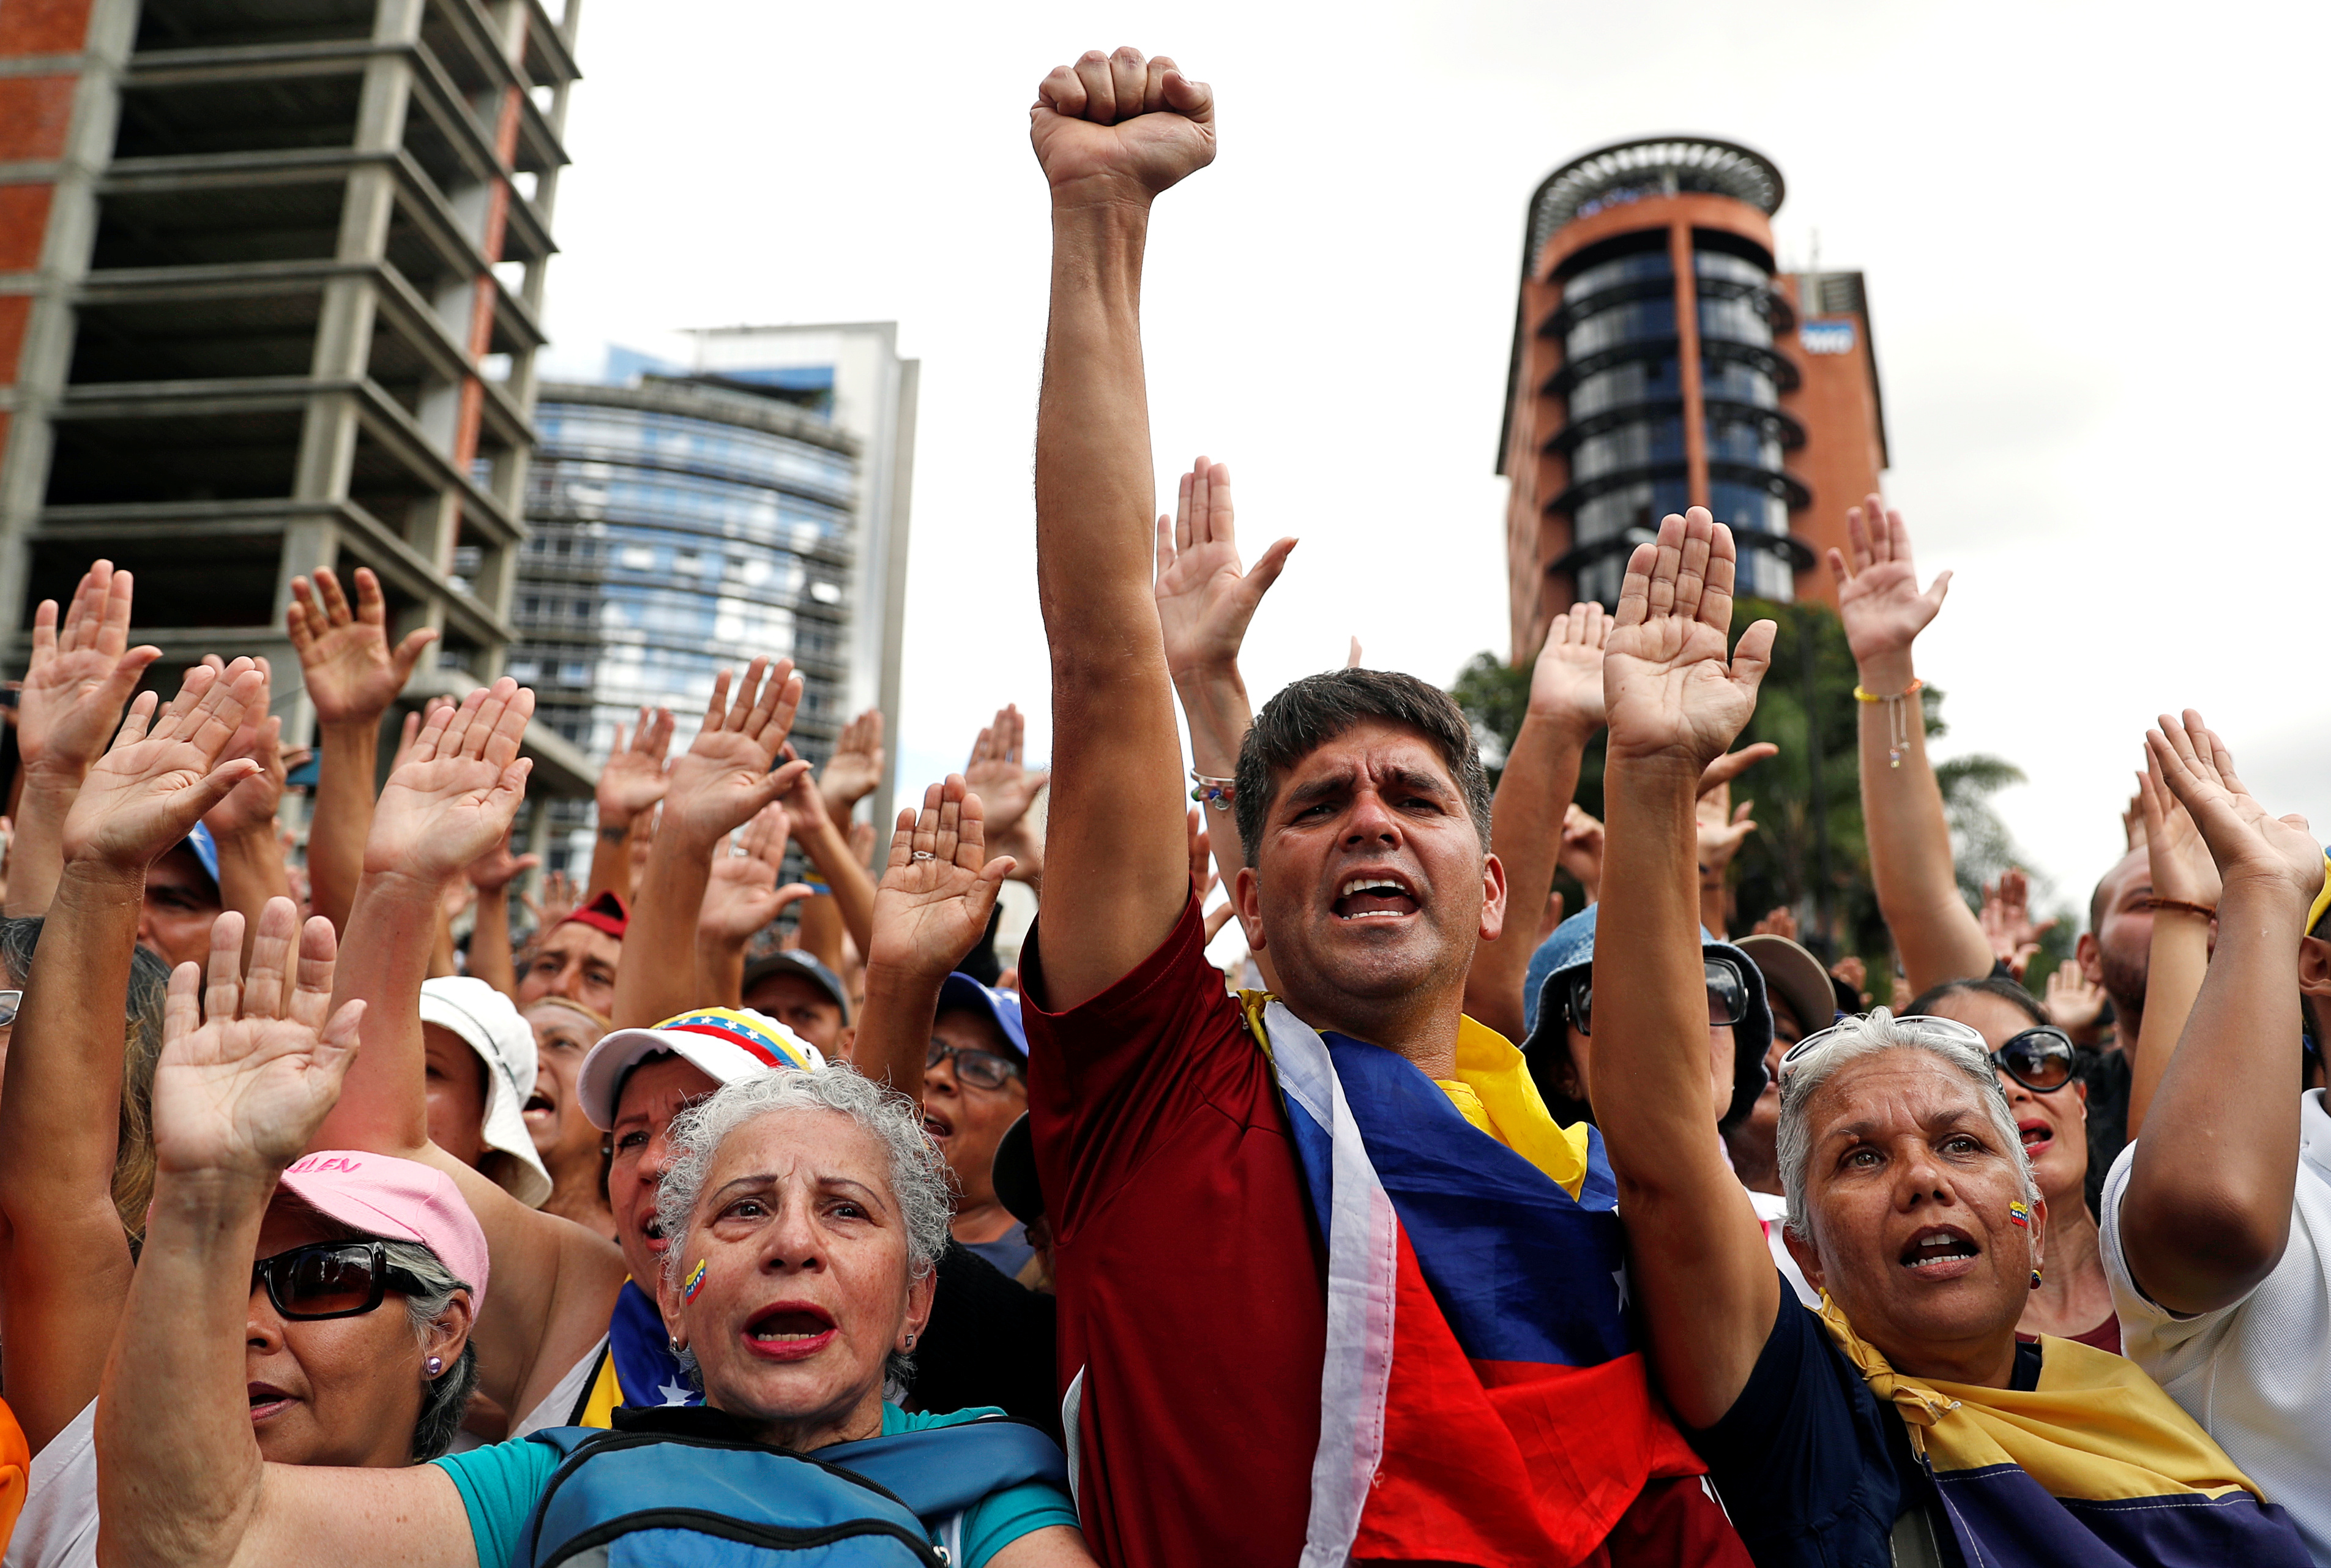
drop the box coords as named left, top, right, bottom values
left=1821, top=1296, right=2308, bottom=1568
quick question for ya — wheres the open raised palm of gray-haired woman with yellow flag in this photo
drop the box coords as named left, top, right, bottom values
left=1604, top=506, right=1776, bottom=776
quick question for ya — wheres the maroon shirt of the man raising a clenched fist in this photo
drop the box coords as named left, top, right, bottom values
left=1021, top=899, right=1326, bottom=1568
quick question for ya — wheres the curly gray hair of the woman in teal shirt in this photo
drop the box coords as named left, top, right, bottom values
left=655, top=1062, right=956, bottom=1384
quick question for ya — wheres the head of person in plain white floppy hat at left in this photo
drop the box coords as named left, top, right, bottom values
left=422, top=974, right=550, bottom=1209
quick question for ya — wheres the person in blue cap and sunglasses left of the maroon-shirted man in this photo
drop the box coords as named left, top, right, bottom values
left=923, top=974, right=1035, bottom=1274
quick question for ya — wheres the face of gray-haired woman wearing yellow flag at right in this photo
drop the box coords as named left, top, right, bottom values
left=1788, top=1046, right=2046, bottom=1372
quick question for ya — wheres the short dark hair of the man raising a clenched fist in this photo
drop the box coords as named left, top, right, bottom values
left=1238, top=669, right=1490, bottom=867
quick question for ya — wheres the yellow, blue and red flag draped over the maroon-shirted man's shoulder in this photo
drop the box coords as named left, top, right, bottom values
left=1245, top=993, right=1746, bottom=1568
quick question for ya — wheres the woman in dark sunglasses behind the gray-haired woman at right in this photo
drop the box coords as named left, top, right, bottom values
left=1909, top=976, right=2121, bottom=1354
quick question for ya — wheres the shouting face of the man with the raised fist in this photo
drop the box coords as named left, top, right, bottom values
left=1238, top=720, right=1506, bottom=1018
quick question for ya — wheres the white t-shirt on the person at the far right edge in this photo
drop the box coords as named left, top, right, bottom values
left=2100, top=1088, right=2331, bottom=1566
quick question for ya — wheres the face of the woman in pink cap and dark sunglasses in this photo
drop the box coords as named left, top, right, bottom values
left=242, top=1202, right=469, bottom=1468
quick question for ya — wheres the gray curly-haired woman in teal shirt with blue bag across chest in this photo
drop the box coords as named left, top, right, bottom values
left=98, top=990, right=1093, bottom=1568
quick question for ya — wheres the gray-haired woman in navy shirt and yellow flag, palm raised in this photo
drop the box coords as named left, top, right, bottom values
left=1592, top=508, right=2308, bottom=1568
